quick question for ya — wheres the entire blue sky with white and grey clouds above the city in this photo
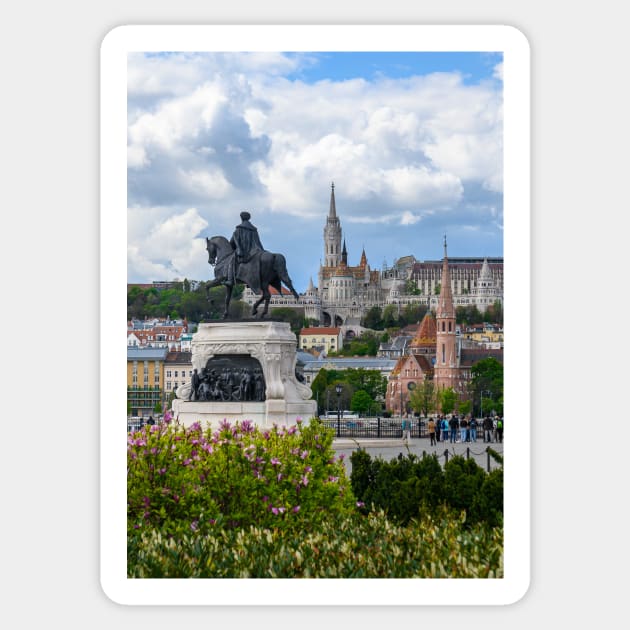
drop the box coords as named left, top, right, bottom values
left=127, top=52, right=503, bottom=292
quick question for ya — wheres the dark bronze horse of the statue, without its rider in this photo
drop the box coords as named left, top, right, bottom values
left=206, top=236, right=300, bottom=319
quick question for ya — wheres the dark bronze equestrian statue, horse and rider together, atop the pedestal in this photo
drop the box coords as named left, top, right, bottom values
left=206, top=212, right=300, bottom=319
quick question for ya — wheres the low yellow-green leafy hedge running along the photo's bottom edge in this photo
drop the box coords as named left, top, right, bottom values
left=128, top=510, right=503, bottom=578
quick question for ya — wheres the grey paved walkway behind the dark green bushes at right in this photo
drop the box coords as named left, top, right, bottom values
left=333, top=437, right=503, bottom=474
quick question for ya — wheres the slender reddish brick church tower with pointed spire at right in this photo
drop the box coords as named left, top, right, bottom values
left=434, top=236, right=459, bottom=391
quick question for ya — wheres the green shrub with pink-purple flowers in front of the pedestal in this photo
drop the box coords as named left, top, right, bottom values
left=127, top=420, right=354, bottom=538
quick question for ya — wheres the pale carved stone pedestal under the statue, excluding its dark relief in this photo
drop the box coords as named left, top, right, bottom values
left=173, top=320, right=317, bottom=427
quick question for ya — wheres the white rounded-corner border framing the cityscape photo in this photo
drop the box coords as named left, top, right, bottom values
left=100, top=25, right=531, bottom=606
